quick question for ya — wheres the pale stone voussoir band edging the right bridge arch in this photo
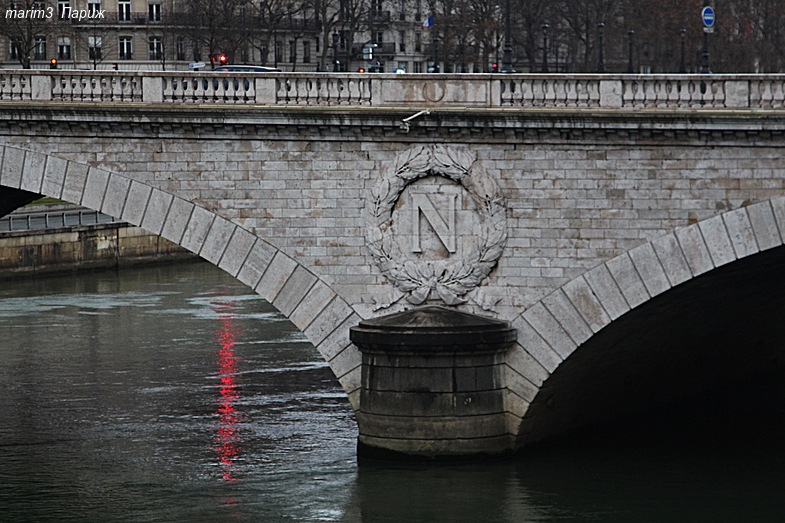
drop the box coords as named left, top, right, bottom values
left=506, top=197, right=785, bottom=442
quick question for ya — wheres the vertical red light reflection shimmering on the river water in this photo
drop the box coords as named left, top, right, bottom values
left=213, top=301, right=242, bottom=481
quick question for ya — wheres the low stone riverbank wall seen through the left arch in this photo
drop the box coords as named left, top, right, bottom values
left=0, top=222, right=195, bottom=279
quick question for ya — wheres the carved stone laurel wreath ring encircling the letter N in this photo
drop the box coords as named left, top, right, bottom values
left=366, top=145, right=507, bottom=305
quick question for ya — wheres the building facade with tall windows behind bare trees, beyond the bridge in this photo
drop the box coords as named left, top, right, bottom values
left=0, top=0, right=478, bottom=73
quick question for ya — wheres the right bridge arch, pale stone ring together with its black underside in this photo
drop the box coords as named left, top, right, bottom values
left=506, top=197, right=785, bottom=446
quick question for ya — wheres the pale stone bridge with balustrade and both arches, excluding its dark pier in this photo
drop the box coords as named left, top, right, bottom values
left=0, top=71, right=785, bottom=458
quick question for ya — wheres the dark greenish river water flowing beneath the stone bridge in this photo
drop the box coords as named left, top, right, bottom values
left=0, top=263, right=785, bottom=523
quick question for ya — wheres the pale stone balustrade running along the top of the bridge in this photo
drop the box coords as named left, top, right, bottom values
left=0, top=70, right=785, bottom=110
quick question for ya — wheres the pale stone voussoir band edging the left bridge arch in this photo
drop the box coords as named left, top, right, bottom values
left=0, top=145, right=361, bottom=410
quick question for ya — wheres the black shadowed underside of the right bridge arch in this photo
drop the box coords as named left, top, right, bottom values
left=519, top=246, right=785, bottom=444
